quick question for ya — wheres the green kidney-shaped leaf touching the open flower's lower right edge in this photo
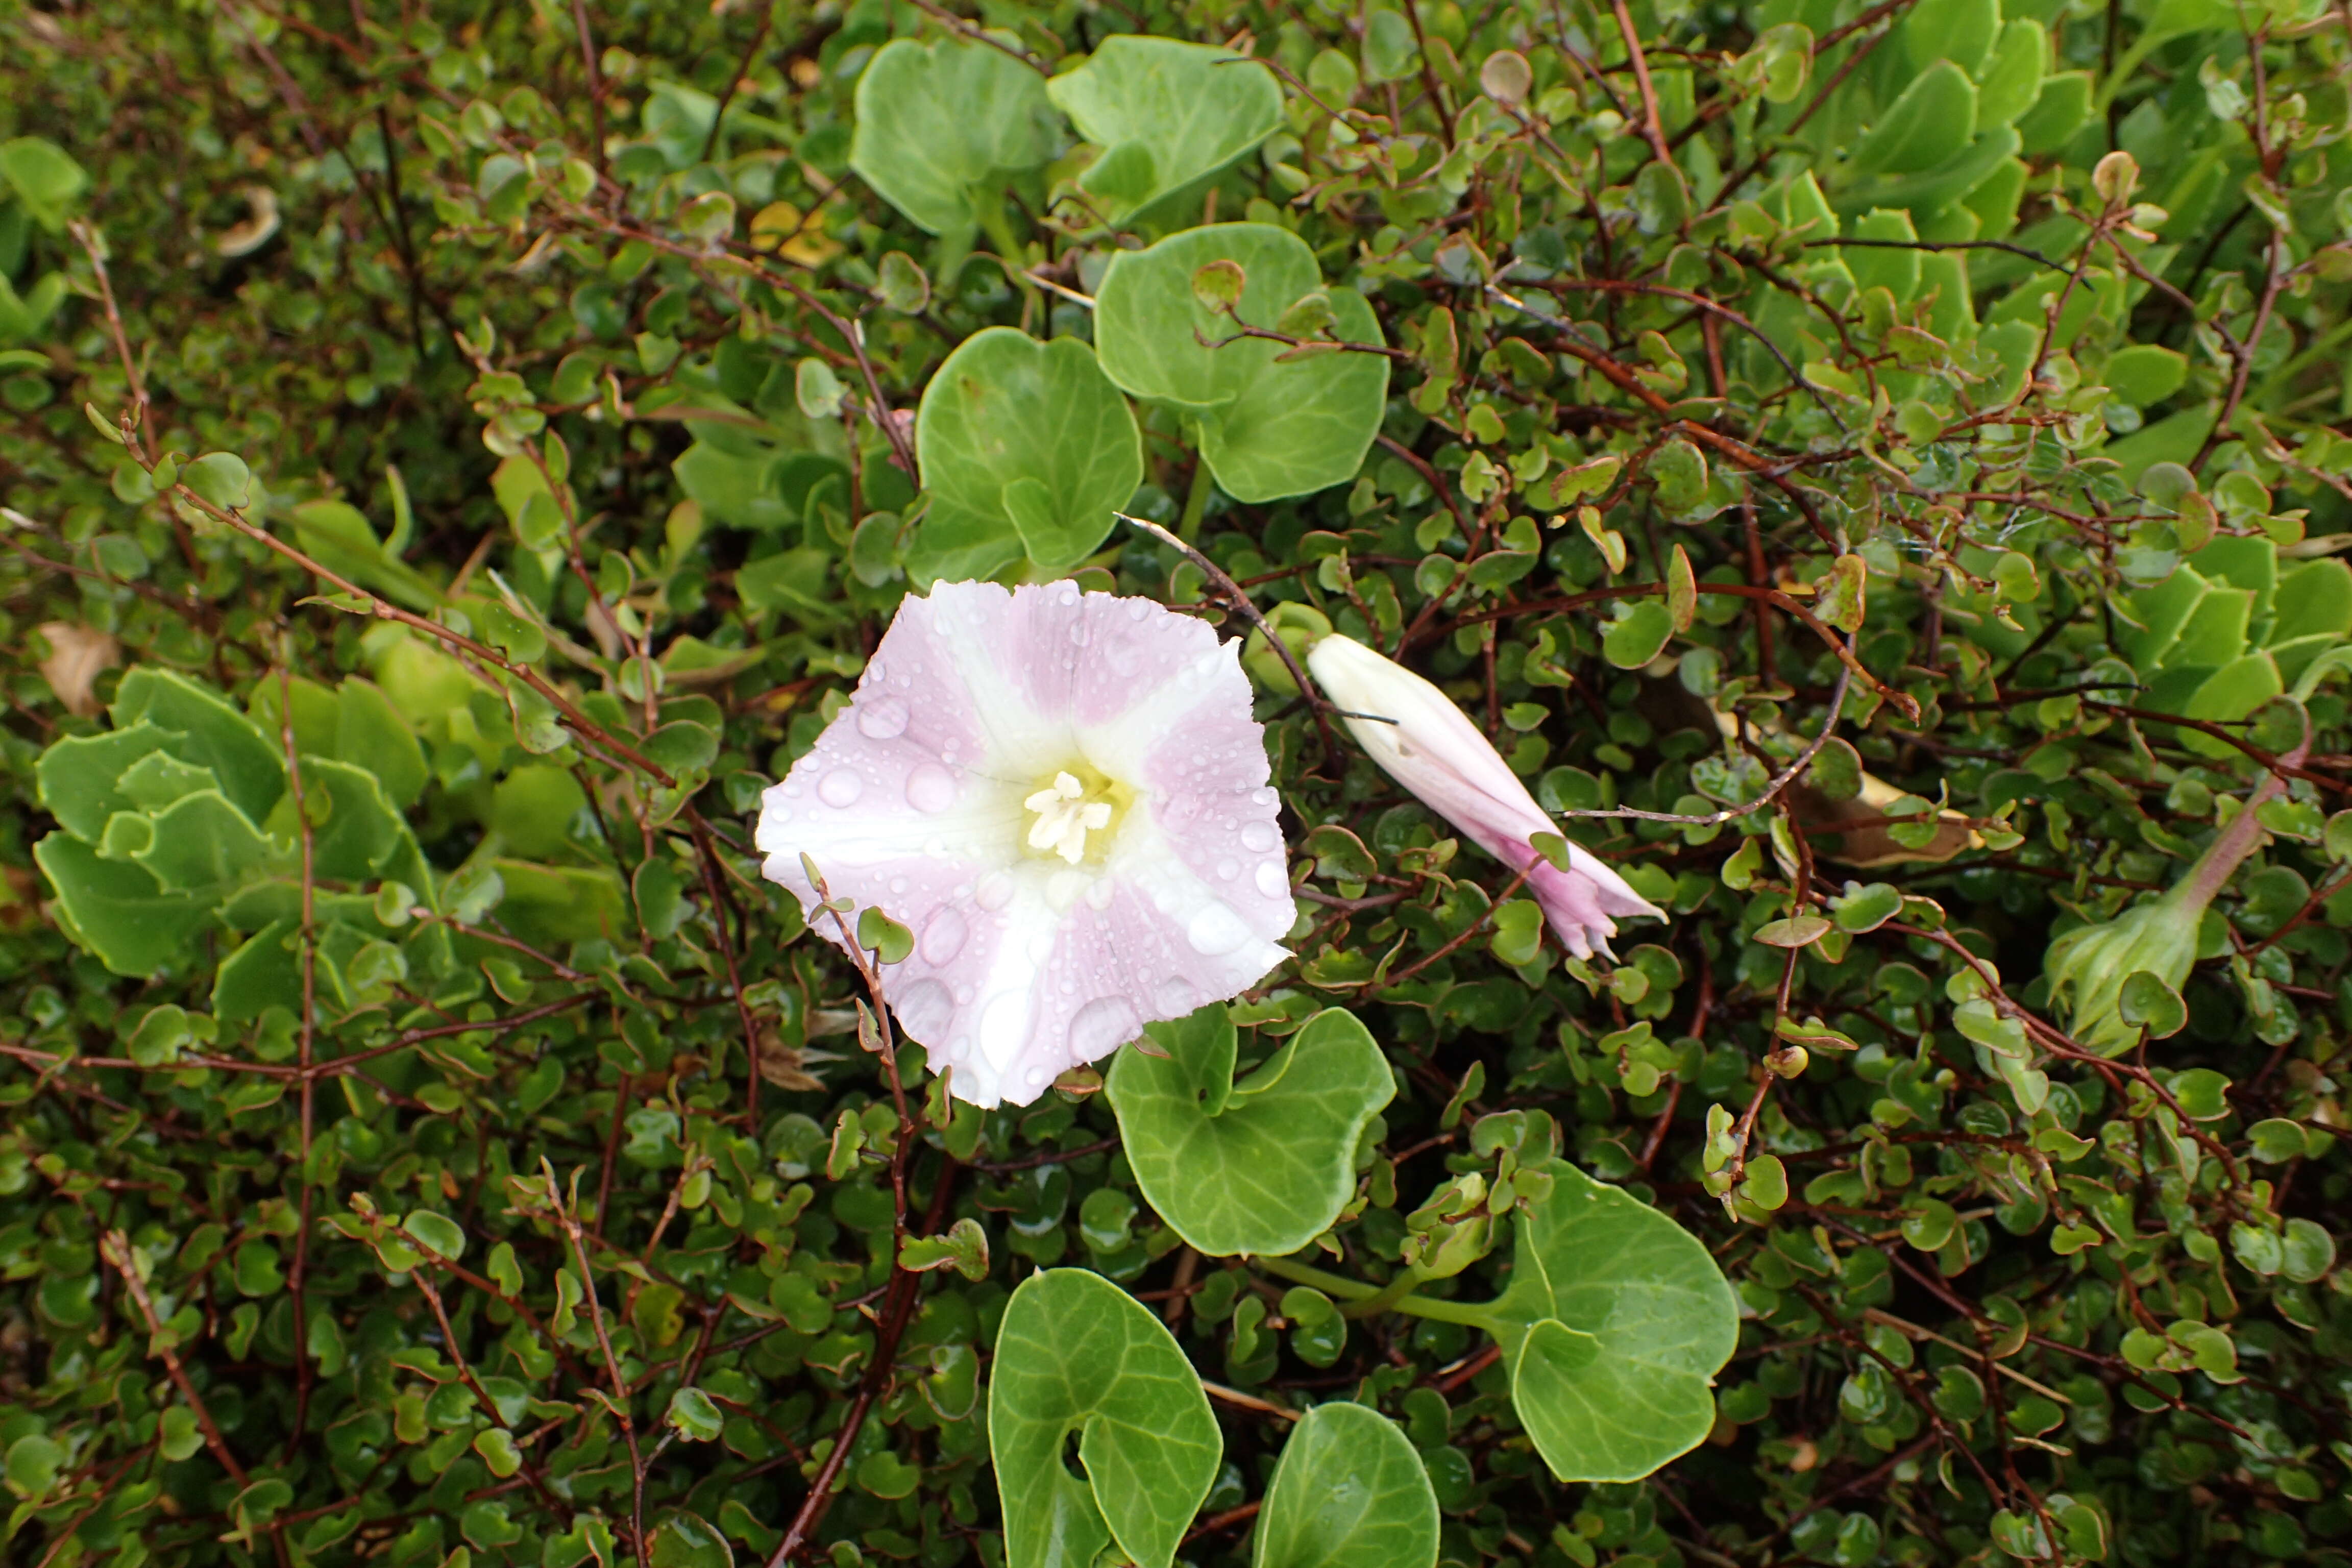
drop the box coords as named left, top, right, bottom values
left=1108, top=1004, right=1397, bottom=1258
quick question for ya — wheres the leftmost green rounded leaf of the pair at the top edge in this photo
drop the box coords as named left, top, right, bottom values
left=849, top=38, right=1056, bottom=235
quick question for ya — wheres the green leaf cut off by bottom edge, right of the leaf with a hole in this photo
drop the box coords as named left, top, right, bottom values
left=1251, top=1401, right=1437, bottom=1568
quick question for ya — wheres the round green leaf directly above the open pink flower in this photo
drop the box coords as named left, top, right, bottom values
left=915, top=327, right=1143, bottom=571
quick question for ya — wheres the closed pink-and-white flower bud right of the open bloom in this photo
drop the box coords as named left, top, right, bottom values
left=1308, top=632, right=1665, bottom=959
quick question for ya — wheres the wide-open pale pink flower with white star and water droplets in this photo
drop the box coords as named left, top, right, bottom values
left=757, top=583, right=1296, bottom=1105
